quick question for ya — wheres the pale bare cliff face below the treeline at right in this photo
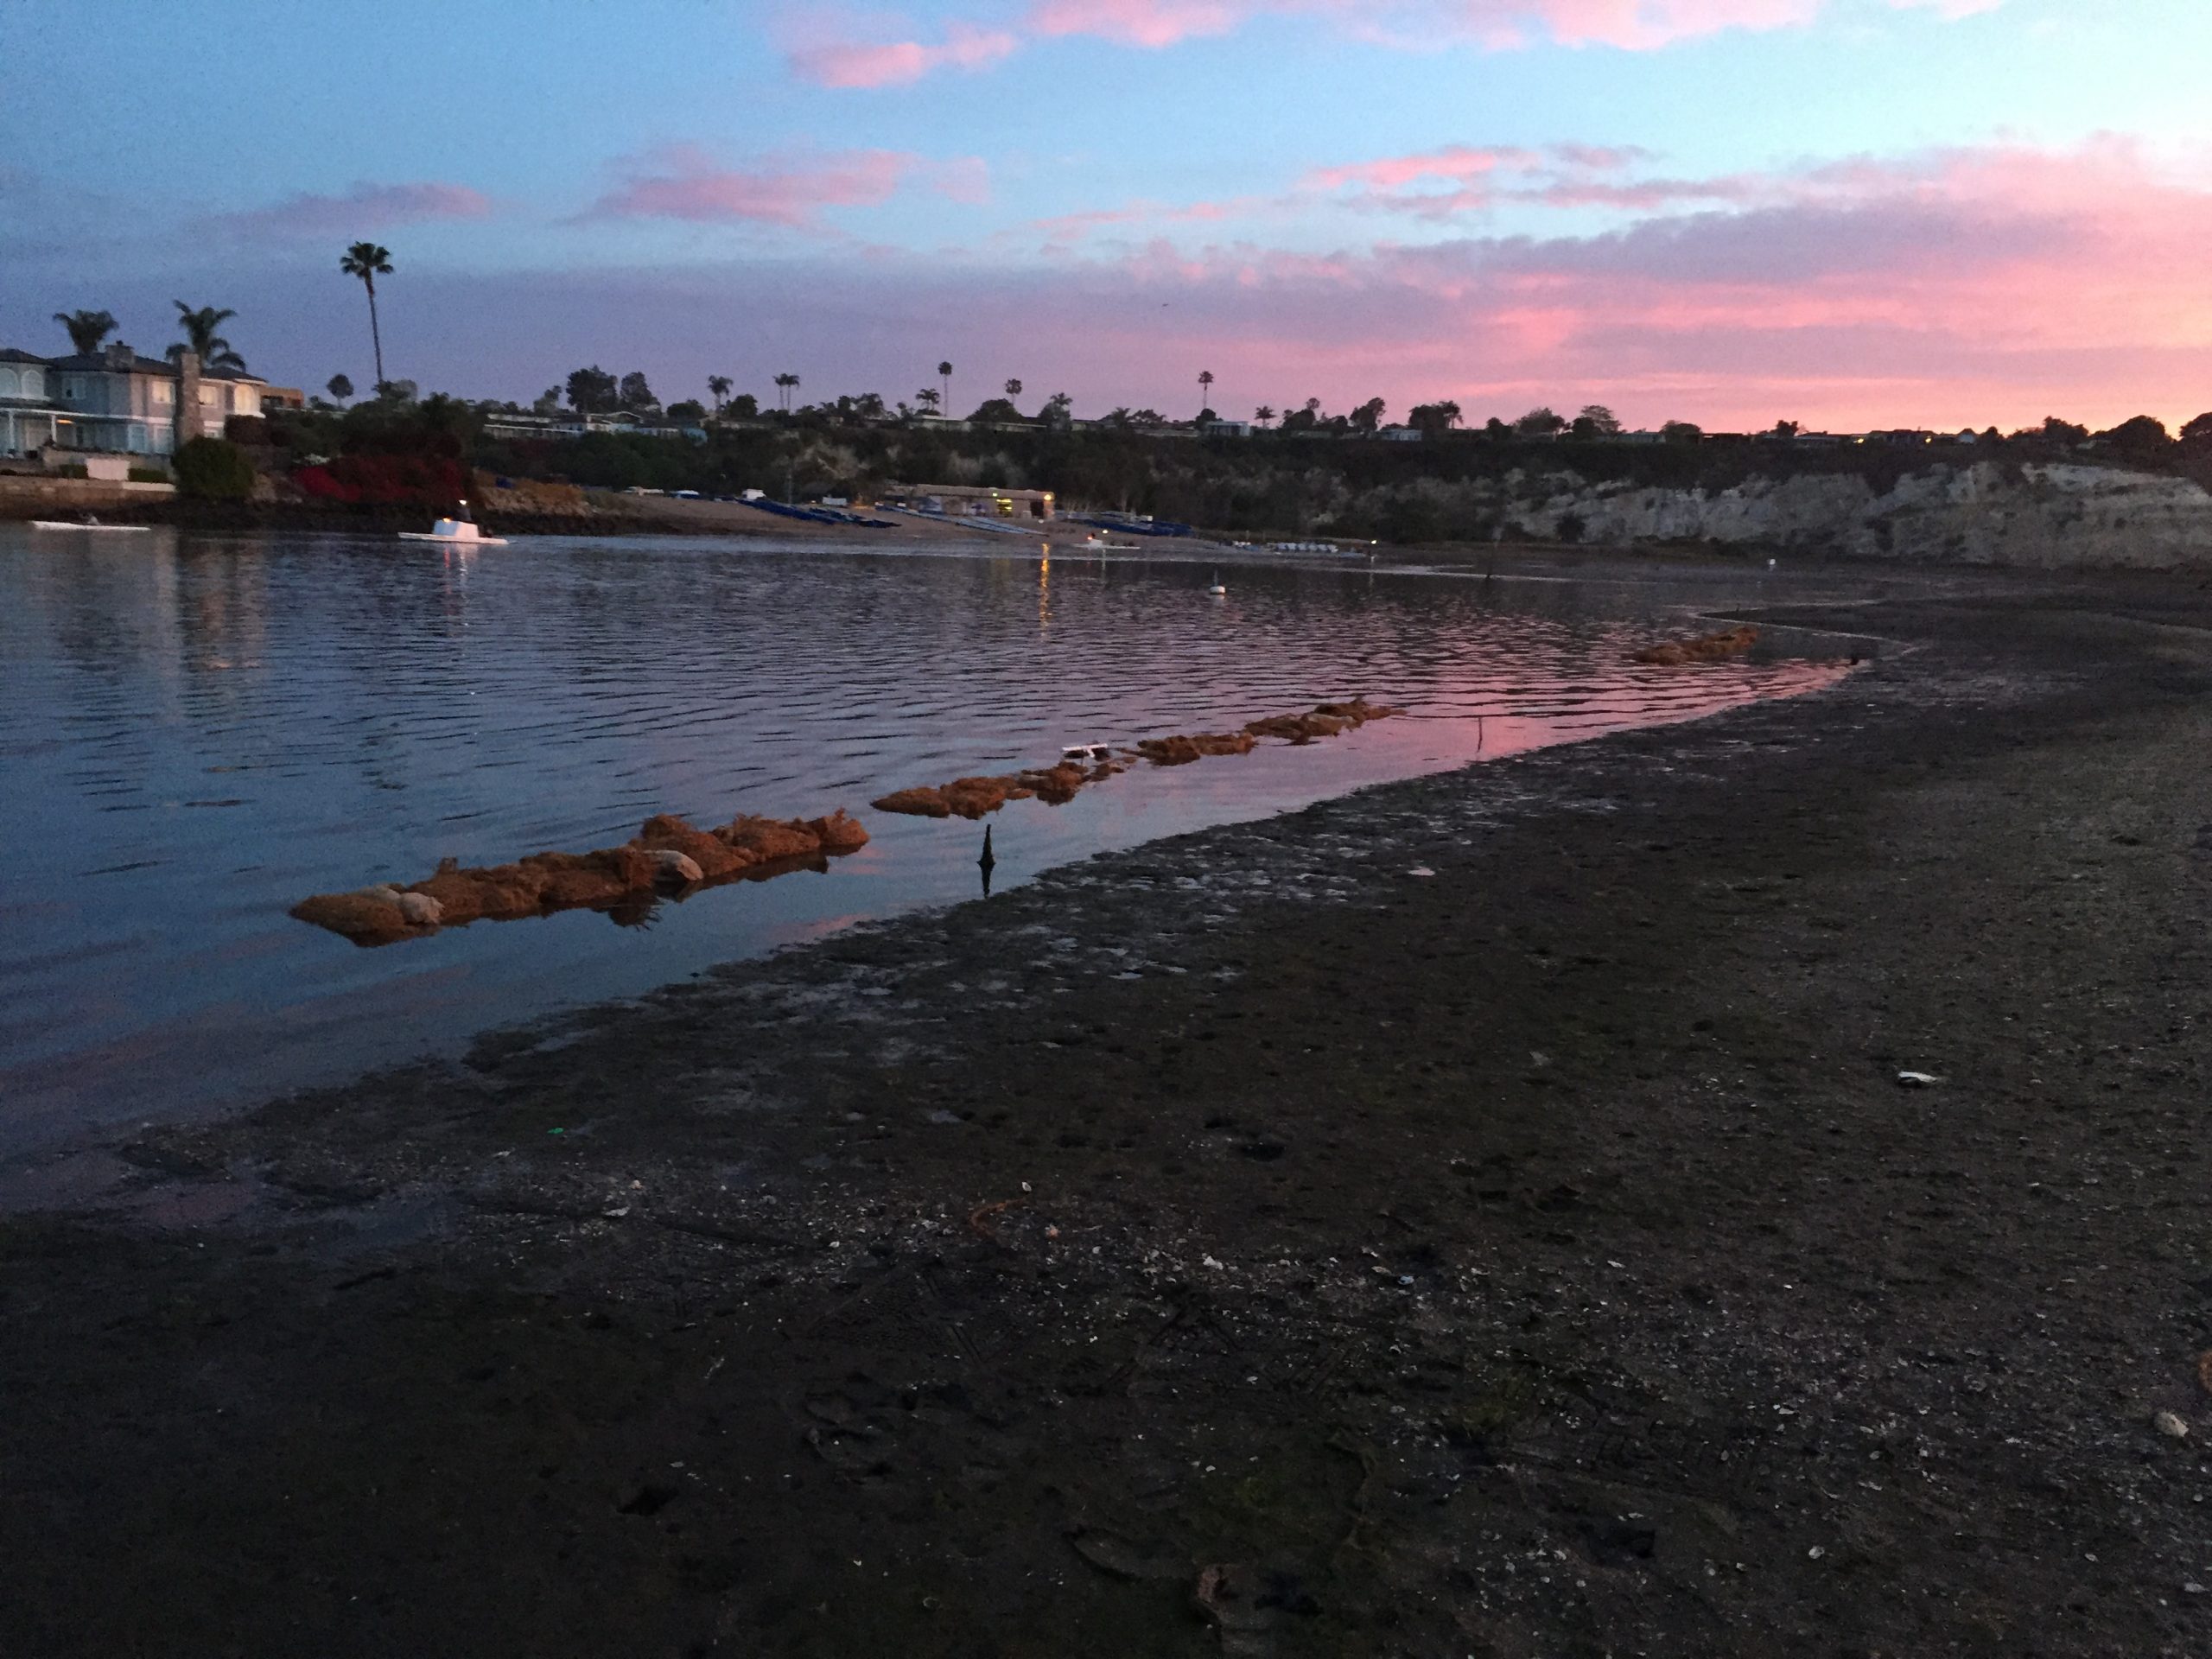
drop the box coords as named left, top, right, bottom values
left=1509, top=462, right=2212, bottom=569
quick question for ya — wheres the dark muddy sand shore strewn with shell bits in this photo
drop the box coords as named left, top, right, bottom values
left=0, top=577, right=2212, bottom=1659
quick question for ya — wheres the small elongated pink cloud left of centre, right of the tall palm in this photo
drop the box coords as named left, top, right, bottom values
left=582, top=146, right=988, bottom=230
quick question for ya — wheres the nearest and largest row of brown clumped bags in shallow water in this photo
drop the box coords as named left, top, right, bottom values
left=292, top=807, right=868, bottom=944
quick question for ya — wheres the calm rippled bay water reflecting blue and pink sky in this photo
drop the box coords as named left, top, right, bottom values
left=0, top=524, right=1834, bottom=1150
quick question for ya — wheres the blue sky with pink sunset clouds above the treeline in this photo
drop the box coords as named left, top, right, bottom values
left=0, top=0, right=2212, bottom=431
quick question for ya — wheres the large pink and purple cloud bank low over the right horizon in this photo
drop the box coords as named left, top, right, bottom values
left=991, top=139, right=2212, bottom=429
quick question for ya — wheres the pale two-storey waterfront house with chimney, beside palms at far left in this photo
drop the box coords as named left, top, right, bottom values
left=0, top=345, right=268, bottom=465
